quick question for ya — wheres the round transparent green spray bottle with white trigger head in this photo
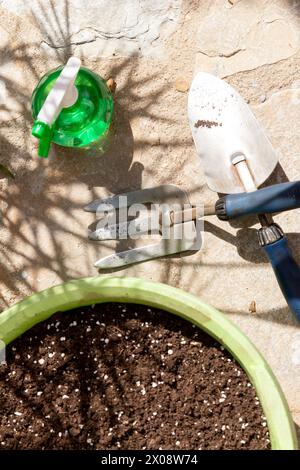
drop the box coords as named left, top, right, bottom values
left=32, top=57, right=114, bottom=158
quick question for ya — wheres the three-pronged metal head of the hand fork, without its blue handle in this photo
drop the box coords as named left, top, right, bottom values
left=84, top=185, right=202, bottom=269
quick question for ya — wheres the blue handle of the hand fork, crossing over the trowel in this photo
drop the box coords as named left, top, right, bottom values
left=216, top=181, right=300, bottom=220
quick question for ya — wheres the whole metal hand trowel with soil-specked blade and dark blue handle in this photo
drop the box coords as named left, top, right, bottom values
left=188, top=72, right=300, bottom=320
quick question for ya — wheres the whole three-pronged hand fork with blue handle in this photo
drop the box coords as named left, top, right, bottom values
left=84, top=182, right=300, bottom=269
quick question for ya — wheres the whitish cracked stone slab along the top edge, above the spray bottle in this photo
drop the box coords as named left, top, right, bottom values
left=0, top=0, right=181, bottom=59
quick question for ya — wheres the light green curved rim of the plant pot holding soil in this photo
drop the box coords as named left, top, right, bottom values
left=0, top=277, right=298, bottom=450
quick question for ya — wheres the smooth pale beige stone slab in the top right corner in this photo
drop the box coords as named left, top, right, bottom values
left=196, top=0, right=300, bottom=77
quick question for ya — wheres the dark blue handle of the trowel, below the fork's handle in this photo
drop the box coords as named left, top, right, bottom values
left=258, top=224, right=300, bottom=321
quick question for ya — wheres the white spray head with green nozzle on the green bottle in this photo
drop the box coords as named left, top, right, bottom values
left=32, top=57, right=81, bottom=158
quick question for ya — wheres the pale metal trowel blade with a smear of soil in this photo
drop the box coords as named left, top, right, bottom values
left=188, top=72, right=278, bottom=194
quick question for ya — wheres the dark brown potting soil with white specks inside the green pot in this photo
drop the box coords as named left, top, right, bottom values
left=0, top=303, right=270, bottom=450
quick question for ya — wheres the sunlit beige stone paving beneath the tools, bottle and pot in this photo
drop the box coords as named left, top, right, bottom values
left=0, top=0, right=300, bottom=440
